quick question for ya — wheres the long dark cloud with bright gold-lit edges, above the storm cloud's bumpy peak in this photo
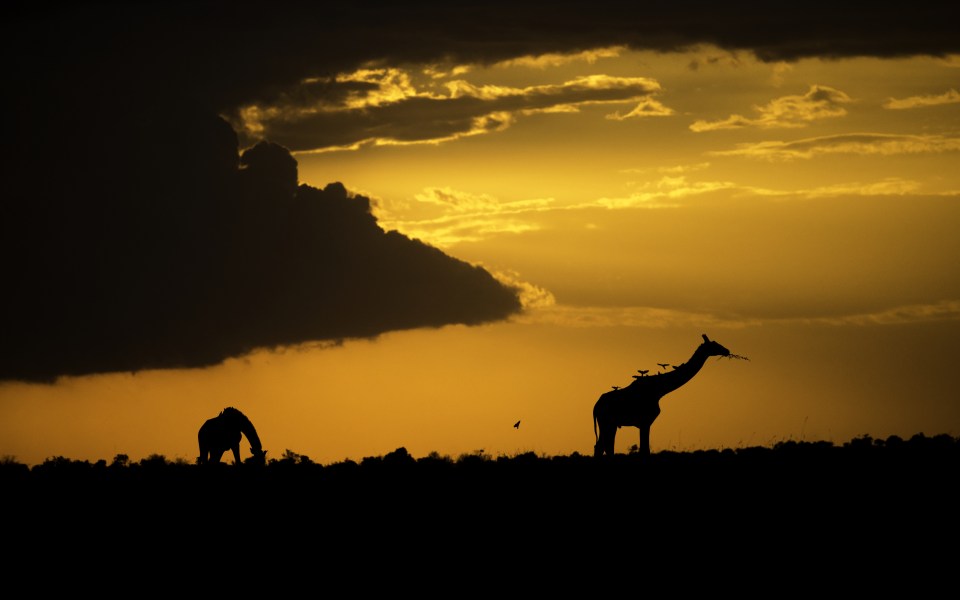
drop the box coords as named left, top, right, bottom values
left=234, top=74, right=671, bottom=152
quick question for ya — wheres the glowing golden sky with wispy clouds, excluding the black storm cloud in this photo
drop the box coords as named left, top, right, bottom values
left=0, top=3, right=960, bottom=464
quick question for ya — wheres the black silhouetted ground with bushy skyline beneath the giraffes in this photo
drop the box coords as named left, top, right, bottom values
left=0, top=434, right=960, bottom=596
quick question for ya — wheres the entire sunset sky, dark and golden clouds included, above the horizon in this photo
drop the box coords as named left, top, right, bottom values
left=0, top=0, right=960, bottom=464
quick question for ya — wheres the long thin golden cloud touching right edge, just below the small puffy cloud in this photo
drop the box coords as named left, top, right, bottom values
left=709, top=133, right=960, bottom=160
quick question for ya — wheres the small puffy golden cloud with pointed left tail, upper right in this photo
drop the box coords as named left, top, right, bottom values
left=690, top=85, right=852, bottom=132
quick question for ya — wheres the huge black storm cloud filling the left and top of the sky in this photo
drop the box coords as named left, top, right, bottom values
left=0, top=0, right=960, bottom=381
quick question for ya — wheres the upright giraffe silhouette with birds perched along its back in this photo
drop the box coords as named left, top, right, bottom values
left=593, top=334, right=731, bottom=456
